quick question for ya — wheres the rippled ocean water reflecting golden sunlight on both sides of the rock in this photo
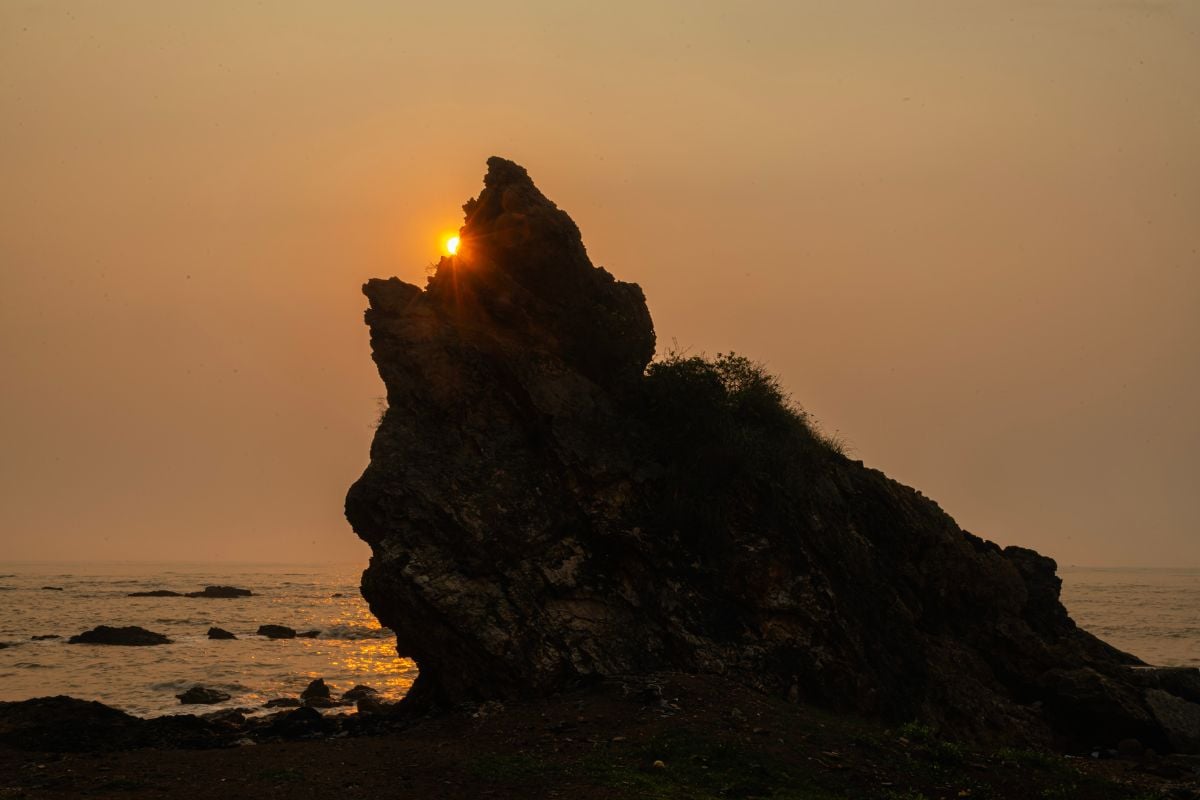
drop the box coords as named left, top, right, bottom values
left=0, top=563, right=1200, bottom=716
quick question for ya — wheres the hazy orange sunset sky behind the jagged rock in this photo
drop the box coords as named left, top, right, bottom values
left=0, top=0, right=1200, bottom=567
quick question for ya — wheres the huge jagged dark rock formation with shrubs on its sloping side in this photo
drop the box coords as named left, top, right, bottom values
left=346, top=158, right=1200, bottom=747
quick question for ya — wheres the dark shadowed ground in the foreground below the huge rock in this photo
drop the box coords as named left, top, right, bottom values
left=0, top=675, right=1200, bottom=800
